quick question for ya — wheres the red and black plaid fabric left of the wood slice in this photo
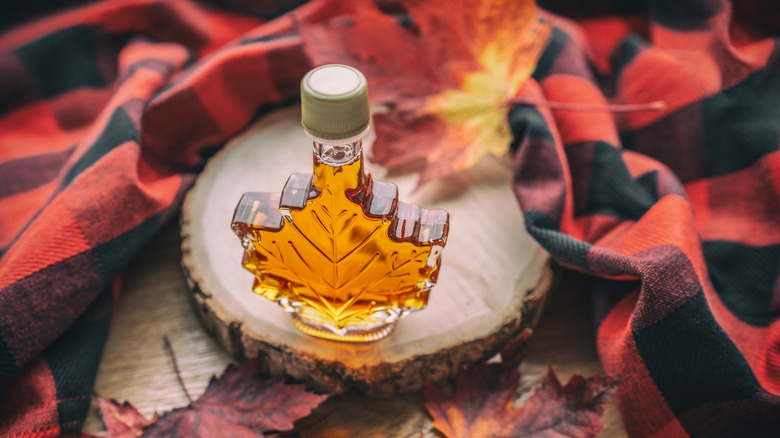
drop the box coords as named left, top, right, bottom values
left=0, top=0, right=309, bottom=437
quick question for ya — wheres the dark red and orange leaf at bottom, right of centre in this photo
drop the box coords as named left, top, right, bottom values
left=425, top=336, right=617, bottom=438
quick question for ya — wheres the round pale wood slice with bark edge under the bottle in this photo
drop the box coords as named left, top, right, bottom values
left=181, top=107, right=553, bottom=396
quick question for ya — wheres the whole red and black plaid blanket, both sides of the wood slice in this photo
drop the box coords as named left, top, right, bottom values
left=0, top=0, right=780, bottom=437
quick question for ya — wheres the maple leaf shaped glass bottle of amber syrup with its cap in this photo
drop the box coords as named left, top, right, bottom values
left=232, top=65, right=449, bottom=342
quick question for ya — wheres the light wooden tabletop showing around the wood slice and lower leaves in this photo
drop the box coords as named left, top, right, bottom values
left=84, top=224, right=626, bottom=438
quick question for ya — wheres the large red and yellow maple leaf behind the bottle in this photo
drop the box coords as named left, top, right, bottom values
left=298, top=0, right=551, bottom=184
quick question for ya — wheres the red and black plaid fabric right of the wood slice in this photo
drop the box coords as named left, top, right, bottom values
left=510, top=0, right=780, bottom=437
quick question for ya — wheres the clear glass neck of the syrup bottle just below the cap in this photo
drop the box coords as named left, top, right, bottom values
left=312, top=138, right=366, bottom=191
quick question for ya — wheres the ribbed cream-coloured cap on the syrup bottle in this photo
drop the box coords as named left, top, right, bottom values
left=301, top=64, right=371, bottom=140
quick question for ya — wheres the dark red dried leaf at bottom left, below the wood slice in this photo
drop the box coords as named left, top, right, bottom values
left=98, top=360, right=328, bottom=438
